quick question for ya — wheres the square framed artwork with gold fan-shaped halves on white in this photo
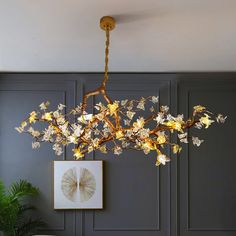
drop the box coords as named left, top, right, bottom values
left=54, top=161, right=103, bottom=210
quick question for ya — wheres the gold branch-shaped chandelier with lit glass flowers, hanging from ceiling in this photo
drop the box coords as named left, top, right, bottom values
left=16, top=16, right=227, bottom=166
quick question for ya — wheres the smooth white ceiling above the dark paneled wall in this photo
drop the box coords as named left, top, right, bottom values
left=0, top=0, right=236, bottom=72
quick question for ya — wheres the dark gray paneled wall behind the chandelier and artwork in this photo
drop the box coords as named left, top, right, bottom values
left=0, top=73, right=236, bottom=236
